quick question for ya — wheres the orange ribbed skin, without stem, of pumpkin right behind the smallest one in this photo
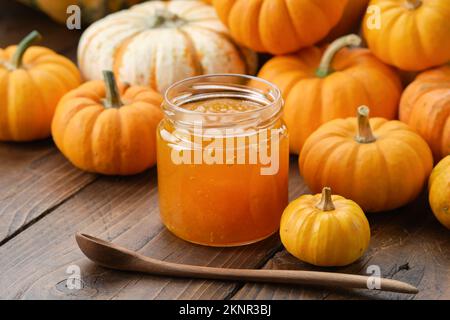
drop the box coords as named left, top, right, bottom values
left=299, top=118, right=433, bottom=212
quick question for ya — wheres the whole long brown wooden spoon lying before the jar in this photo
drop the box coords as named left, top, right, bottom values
left=76, top=233, right=419, bottom=293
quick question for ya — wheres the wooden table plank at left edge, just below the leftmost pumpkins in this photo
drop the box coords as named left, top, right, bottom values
left=0, top=141, right=95, bottom=244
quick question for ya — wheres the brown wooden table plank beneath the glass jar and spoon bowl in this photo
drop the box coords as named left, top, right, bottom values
left=0, top=159, right=307, bottom=299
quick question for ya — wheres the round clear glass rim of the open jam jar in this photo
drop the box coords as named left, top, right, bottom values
left=163, top=73, right=283, bottom=117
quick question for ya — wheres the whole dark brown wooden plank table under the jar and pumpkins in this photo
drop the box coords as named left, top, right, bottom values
left=0, top=0, right=450, bottom=299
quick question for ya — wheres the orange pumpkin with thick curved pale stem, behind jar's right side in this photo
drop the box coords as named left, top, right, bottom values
left=259, top=35, right=402, bottom=153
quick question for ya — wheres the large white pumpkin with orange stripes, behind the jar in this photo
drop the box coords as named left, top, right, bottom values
left=78, top=1, right=257, bottom=92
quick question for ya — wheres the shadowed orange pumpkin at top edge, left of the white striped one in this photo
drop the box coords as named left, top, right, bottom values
left=19, top=0, right=143, bottom=24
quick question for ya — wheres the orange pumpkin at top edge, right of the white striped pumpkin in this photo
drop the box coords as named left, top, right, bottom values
left=213, top=0, right=347, bottom=54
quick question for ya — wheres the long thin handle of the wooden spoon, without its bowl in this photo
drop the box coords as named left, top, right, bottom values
left=134, top=260, right=418, bottom=294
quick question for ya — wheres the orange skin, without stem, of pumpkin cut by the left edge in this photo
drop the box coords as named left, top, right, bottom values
left=0, top=46, right=81, bottom=142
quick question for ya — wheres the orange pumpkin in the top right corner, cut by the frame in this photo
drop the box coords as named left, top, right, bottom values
left=363, top=0, right=450, bottom=71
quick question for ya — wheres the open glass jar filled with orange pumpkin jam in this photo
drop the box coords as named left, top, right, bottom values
left=157, top=75, right=289, bottom=246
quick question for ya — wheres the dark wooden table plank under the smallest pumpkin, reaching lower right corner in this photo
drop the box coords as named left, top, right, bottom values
left=233, top=193, right=450, bottom=299
